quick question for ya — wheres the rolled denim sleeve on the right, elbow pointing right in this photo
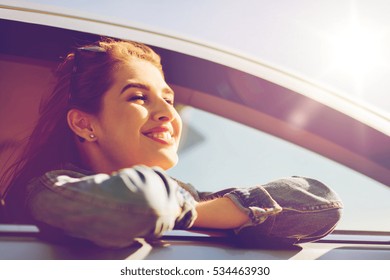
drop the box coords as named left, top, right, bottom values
left=224, top=177, right=343, bottom=247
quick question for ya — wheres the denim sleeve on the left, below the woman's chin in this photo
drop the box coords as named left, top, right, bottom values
left=26, top=166, right=196, bottom=247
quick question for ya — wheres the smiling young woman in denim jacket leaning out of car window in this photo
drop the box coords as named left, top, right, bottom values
left=0, top=39, right=342, bottom=247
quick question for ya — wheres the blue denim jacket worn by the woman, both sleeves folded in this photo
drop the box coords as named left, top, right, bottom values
left=22, top=166, right=342, bottom=247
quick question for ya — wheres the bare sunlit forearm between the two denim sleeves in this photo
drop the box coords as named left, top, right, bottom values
left=193, top=197, right=249, bottom=229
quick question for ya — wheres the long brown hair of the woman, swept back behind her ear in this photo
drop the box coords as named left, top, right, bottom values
left=1, top=38, right=163, bottom=221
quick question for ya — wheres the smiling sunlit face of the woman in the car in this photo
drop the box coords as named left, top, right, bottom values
left=90, top=59, right=182, bottom=171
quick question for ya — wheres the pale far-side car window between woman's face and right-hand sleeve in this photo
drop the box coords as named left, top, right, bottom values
left=169, top=107, right=390, bottom=231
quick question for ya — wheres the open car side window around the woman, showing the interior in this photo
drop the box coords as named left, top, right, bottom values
left=0, top=20, right=390, bottom=236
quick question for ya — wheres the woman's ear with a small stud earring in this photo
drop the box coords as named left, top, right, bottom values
left=67, top=109, right=96, bottom=142
